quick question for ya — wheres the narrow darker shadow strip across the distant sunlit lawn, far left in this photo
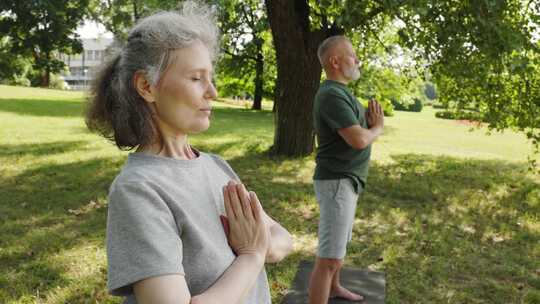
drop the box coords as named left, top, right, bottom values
left=0, top=99, right=83, bottom=117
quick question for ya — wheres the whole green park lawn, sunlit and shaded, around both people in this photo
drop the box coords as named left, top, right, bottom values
left=0, top=86, right=540, bottom=303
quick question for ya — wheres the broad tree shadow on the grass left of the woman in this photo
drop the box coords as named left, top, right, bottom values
left=0, top=156, right=124, bottom=302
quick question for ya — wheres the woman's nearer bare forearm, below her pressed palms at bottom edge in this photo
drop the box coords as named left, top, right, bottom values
left=190, top=254, right=264, bottom=304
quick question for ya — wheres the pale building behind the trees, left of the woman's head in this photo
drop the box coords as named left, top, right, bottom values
left=59, top=37, right=113, bottom=90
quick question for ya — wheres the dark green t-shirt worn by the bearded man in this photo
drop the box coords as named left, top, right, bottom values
left=313, top=80, right=371, bottom=190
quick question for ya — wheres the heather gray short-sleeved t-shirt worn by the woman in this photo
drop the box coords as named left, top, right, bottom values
left=107, top=153, right=270, bottom=304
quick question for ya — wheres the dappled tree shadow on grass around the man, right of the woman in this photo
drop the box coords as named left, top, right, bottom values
left=198, top=147, right=540, bottom=303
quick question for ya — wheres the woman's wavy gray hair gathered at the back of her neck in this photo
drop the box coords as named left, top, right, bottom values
left=86, top=1, right=219, bottom=149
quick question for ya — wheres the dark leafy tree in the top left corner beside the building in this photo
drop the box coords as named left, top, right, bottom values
left=0, top=0, right=88, bottom=87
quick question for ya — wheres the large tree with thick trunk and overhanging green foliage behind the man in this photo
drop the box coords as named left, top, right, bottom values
left=265, top=0, right=540, bottom=155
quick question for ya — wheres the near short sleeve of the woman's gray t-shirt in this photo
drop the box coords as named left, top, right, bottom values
left=107, top=183, right=184, bottom=295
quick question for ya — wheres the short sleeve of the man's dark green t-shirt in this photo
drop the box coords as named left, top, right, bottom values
left=320, top=93, right=359, bottom=131
